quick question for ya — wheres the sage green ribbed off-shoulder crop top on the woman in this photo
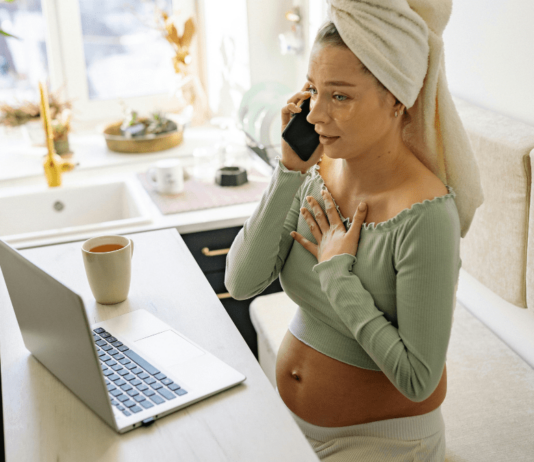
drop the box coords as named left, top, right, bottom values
left=224, top=158, right=462, bottom=402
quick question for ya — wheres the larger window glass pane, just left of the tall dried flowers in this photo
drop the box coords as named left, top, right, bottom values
left=79, top=0, right=174, bottom=100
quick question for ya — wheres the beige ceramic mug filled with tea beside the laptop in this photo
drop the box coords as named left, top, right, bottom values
left=82, top=235, right=134, bottom=305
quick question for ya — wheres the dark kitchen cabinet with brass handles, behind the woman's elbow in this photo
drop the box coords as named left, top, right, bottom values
left=181, top=226, right=283, bottom=359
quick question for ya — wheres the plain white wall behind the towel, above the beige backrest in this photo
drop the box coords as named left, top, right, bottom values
left=443, top=0, right=534, bottom=125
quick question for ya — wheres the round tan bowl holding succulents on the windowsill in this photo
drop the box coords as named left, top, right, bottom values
left=104, top=119, right=184, bottom=154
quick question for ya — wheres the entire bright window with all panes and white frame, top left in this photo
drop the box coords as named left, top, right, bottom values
left=0, top=0, right=250, bottom=122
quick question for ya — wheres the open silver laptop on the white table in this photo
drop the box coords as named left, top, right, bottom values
left=0, top=240, right=246, bottom=433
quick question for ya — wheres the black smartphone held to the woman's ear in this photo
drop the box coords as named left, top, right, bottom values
left=282, top=98, right=319, bottom=161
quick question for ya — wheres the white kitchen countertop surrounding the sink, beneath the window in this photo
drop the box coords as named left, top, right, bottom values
left=0, top=125, right=276, bottom=249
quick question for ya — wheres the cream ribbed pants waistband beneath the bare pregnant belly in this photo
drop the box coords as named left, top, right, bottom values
left=276, top=387, right=445, bottom=442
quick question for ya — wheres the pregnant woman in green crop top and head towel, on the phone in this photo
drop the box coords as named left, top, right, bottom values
left=225, top=0, right=483, bottom=462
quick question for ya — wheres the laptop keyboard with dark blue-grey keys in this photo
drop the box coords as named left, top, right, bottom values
left=93, top=327, right=187, bottom=416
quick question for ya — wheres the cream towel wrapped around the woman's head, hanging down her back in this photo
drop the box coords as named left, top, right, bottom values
left=327, top=0, right=484, bottom=237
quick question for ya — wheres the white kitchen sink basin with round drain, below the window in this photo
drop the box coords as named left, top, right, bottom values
left=0, top=180, right=152, bottom=244
